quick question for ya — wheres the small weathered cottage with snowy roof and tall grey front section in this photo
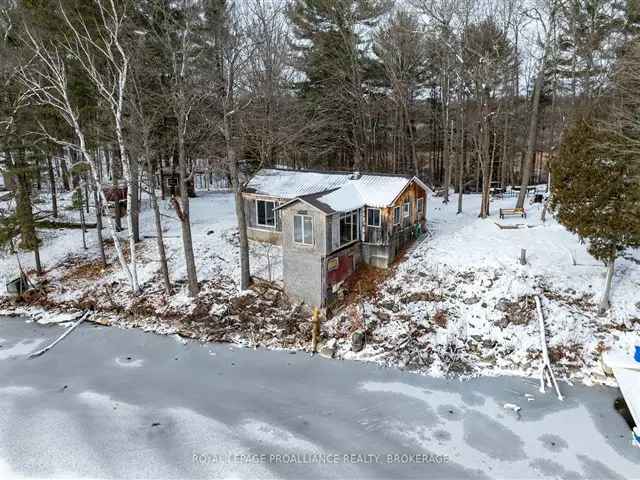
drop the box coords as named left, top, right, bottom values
left=244, top=169, right=427, bottom=306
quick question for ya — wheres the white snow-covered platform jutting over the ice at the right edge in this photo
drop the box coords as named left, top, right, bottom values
left=602, top=351, right=640, bottom=447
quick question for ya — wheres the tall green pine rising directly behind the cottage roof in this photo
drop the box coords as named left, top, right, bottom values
left=289, top=0, right=389, bottom=169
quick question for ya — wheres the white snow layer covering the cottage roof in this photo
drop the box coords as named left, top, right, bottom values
left=247, top=169, right=420, bottom=212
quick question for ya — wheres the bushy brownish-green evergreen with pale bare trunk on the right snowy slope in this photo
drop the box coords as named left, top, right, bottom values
left=550, top=119, right=640, bottom=312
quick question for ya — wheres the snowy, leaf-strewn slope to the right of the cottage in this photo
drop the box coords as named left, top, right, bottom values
left=334, top=195, right=640, bottom=382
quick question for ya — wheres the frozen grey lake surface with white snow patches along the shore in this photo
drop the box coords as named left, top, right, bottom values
left=0, top=318, right=640, bottom=479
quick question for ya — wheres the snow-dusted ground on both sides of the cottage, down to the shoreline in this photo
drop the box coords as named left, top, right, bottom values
left=0, top=188, right=640, bottom=382
